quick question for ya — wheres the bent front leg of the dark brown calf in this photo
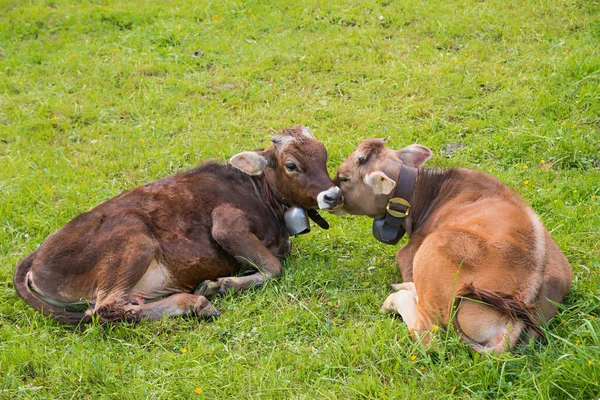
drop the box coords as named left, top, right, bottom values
left=194, top=204, right=281, bottom=297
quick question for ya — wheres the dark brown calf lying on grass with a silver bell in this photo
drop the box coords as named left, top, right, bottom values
left=14, top=125, right=341, bottom=324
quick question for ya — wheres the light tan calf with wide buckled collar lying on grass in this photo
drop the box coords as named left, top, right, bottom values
left=334, top=139, right=571, bottom=352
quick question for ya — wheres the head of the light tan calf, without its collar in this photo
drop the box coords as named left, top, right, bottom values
left=334, top=139, right=432, bottom=218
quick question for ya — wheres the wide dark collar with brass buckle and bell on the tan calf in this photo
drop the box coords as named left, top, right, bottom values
left=373, top=165, right=418, bottom=244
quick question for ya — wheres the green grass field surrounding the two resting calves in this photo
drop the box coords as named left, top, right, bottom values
left=0, top=0, right=600, bottom=399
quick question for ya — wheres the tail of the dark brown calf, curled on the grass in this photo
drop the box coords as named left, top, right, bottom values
left=13, top=252, right=92, bottom=325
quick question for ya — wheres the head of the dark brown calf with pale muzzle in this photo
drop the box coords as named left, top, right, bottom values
left=230, top=125, right=342, bottom=209
